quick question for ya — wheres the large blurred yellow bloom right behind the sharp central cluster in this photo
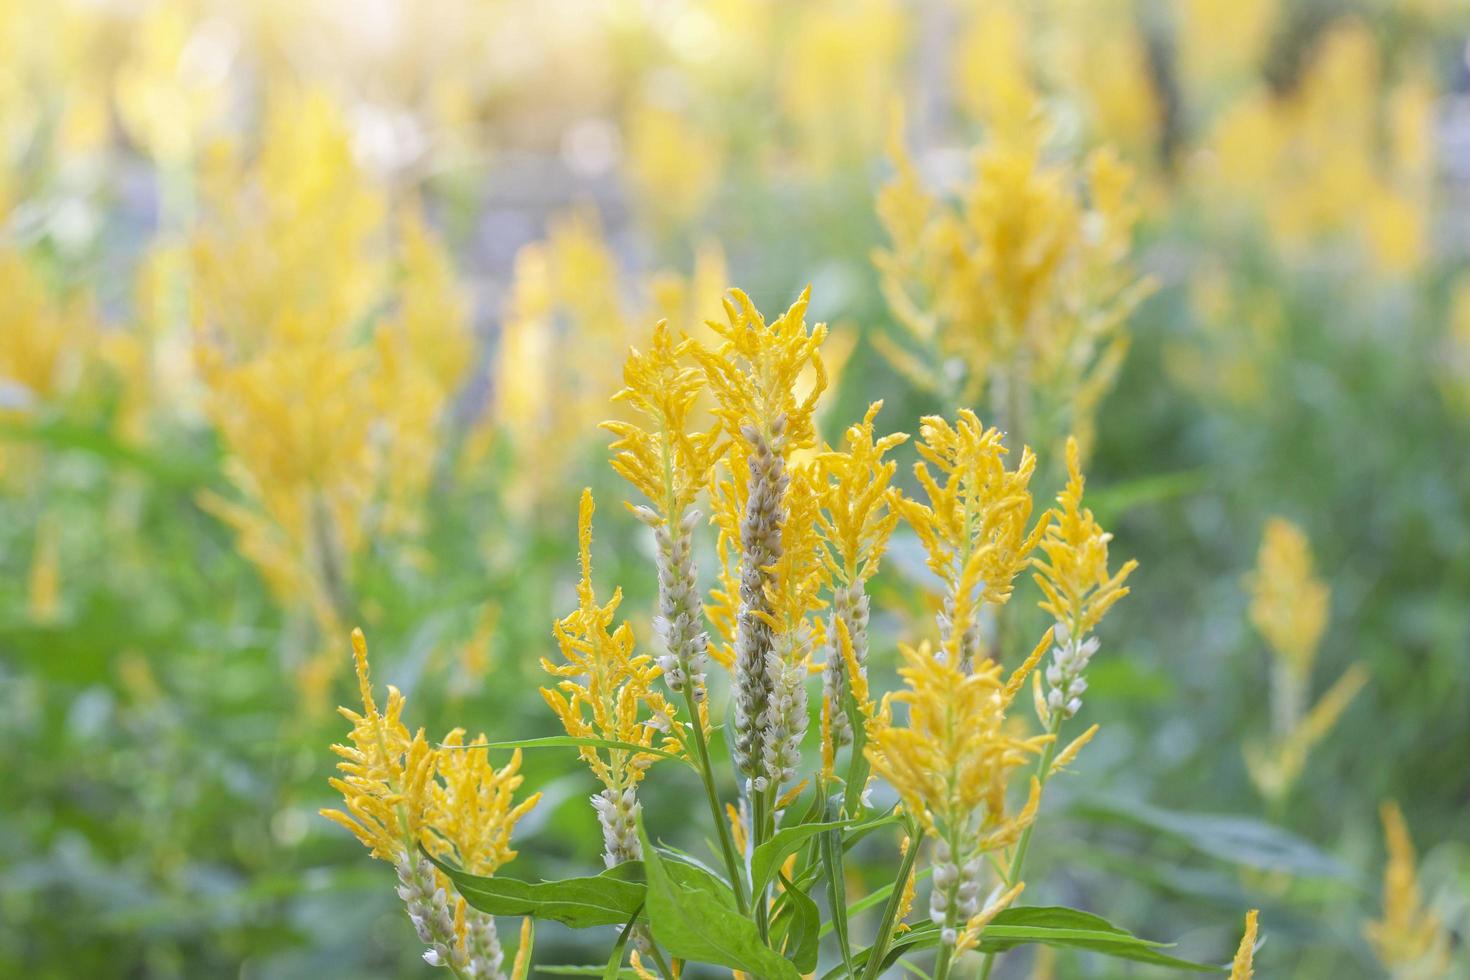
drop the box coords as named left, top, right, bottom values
left=873, top=104, right=1152, bottom=461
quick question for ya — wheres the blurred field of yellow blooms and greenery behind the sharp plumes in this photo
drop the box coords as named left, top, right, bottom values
left=0, top=0, right=1470, bottom=977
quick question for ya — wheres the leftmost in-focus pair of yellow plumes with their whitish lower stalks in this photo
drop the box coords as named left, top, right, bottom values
left=322, top=630, right=541, bottom=980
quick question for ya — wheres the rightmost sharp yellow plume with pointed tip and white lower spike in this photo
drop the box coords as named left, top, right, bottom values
left=1032, top=438, right=1138, bottom=718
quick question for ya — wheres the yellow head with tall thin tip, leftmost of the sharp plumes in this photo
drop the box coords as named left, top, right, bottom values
left=322, top=630, right=438, bottom=861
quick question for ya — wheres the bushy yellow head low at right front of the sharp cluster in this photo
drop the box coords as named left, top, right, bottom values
left=867, top=645, right=1051, bottom=860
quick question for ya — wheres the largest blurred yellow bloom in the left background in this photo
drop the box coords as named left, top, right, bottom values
left=190, top=93, right=475, bottom=646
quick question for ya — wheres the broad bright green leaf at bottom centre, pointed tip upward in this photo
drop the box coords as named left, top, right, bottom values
left=638, top=821, right=801, bottom=980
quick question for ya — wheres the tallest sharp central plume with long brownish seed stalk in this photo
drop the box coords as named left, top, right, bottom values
left=692, top=288, right=826, bottom=785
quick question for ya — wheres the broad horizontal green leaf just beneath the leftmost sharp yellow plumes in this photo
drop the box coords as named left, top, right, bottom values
left=429, top=857, right=647, bottom=929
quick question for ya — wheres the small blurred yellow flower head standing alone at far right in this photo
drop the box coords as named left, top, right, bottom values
left=1247, top=517, right=1332, bottom=680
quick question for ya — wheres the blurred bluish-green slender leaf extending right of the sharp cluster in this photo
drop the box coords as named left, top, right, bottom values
left=1075, top=798, right=1352, bottom=880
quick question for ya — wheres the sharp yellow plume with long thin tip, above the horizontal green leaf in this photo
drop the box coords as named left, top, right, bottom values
left=541, top=489, right=682, bottom=867
